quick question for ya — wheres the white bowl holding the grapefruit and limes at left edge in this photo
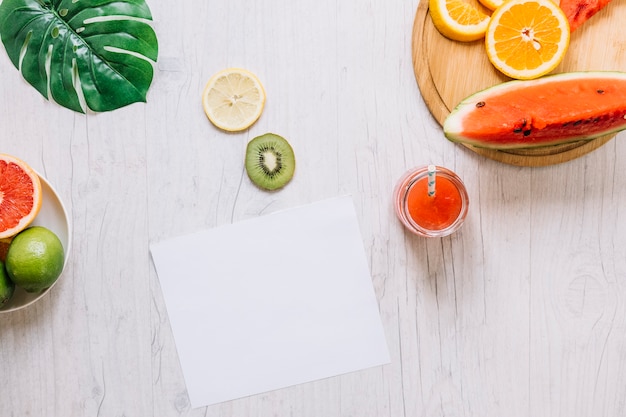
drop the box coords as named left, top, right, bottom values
left=0, top=174, right=72, bottom=314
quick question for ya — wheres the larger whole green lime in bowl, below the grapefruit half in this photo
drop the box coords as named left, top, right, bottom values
left=6, top=226, right=65, bottom=292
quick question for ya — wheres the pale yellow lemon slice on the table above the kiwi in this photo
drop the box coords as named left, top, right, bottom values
left=202, top=68, right=265, bottom=132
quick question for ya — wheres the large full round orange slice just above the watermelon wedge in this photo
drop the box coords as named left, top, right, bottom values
left=485, top=0, right=570, bottom=80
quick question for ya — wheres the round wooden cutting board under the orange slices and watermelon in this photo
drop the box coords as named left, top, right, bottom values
left=412, top=0, right=626, bottom=166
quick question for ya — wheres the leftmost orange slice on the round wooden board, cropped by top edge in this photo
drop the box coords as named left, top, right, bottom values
left=428, top=0, right=489, bottom=42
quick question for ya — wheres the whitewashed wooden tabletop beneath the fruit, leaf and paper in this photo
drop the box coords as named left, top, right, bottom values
left=0, top=0, right=626, bottom=417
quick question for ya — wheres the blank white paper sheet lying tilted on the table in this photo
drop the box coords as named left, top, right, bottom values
left=150, top=196, right=390, bottom=408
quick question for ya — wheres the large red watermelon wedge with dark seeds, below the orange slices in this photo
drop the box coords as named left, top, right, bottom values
left=443, top=71, right=626, bottom=149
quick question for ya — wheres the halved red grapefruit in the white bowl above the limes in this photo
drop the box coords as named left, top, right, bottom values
left=0, top=154, right=42, bottom=239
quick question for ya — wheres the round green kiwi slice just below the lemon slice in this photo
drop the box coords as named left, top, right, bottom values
left=246, top=133, right=296, bottom=190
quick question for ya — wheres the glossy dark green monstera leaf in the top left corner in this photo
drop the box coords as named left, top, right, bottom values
left=0, top=0, right=158, bottom=113
